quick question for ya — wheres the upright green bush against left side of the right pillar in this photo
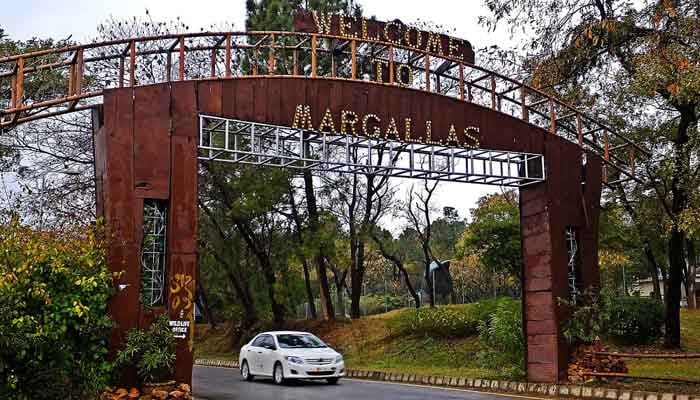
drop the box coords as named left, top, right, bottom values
left=477, top=299, right=525, bottom=377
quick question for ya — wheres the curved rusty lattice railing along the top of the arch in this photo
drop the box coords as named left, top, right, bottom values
left=0, top=32, right=649, bottom=185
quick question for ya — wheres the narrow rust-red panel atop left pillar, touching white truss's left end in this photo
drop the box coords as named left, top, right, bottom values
left=170, top=81, right=199, bottom=138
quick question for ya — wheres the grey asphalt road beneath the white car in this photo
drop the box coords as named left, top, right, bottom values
left=192, top=366, right=540, bottom=400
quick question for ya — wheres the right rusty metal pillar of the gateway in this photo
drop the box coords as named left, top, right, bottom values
left=520, top=138, right=602, bottom=383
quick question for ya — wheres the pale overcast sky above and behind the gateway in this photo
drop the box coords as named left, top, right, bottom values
left=0, top=0, right=509, bottom=225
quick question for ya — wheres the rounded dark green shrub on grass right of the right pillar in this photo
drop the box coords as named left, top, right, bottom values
left=604, top=296, right=664, bottom=344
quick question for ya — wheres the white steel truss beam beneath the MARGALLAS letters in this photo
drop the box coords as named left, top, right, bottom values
left=199, top=115, right=545, bottom=187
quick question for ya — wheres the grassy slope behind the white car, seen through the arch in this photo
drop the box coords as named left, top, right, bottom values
left=195, top=302, right=524, bottom=379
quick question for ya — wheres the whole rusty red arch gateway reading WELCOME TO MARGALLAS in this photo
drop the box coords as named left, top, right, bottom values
left=0, top=12, right=646, bottom=388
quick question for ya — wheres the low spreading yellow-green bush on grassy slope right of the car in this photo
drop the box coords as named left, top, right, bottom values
left=389, top=299, right=517, bottom=338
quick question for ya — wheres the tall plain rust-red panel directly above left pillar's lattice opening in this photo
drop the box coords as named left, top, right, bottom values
left=134, top=85, right=170, bottom=199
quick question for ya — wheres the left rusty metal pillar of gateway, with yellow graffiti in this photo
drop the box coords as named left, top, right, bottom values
left=93, top=83, right=198, bottom=384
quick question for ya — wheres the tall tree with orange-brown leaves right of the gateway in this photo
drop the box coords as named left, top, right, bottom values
left=482, top=0, right=700, bottom=347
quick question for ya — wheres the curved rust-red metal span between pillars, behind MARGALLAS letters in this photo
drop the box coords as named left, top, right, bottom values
left=193, top=77, right=565, bottom=153
